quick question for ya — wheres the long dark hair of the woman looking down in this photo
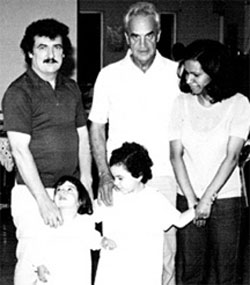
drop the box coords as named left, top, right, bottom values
left=179, top=39, right=236, bottom=103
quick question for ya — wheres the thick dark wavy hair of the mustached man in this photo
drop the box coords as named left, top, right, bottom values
left=20, top=19, right=73, bottom=66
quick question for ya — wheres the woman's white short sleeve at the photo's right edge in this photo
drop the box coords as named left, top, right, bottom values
left=229, top=94, right=250, bottom=139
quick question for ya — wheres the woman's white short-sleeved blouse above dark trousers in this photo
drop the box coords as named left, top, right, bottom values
left=169, top=94, right=250, bottom=198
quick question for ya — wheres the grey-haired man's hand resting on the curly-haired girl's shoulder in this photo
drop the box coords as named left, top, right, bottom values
left=98, top=173, right=115, bottom=206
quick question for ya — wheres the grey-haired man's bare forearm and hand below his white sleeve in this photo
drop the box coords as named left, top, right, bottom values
left=90, top=122, right=114, bottom=206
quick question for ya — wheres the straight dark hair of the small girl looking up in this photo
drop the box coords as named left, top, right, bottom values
left=54, top=175, right=93, bottom=215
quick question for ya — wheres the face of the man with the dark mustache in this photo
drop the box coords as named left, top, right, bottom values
left=29, top=36, right=64, bottom=80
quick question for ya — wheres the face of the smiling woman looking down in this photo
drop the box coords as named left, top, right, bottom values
left=184, top=59, right=211, bottom=95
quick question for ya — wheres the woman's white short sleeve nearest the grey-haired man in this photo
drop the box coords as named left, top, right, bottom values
left=168, top=94, right=184, bottom=141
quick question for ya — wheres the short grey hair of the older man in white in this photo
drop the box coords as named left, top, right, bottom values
left=123, top=2, right=161, bottom=33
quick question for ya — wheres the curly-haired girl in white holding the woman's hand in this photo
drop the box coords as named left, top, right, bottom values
left=95, top=143, right=194, bottom=285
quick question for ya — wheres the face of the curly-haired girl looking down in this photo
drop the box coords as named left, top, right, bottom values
left=110, top=164, right=141, bottom=194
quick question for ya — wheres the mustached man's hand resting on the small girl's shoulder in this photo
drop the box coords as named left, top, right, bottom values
left=38, top=195, right=63, bottom=228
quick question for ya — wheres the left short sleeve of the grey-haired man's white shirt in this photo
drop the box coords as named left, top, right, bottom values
left=89, top=68, right=112, bottom=124
